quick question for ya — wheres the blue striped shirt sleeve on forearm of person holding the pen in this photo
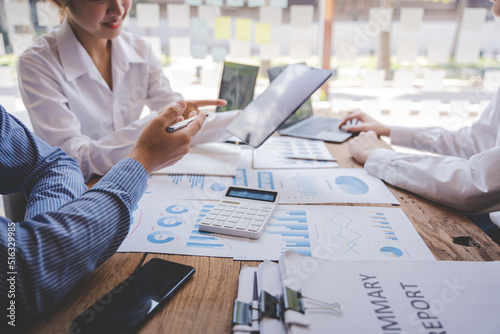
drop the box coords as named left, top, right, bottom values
left=0, top=159, right=147, bottom=314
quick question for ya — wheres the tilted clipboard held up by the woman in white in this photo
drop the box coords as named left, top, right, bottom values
left=226, top=64, right=332, bottom=147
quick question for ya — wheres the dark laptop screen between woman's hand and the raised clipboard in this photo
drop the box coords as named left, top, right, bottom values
left=215, top=62, right=259, bottom=112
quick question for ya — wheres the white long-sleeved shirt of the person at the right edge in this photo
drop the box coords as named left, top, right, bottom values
left=365, top=90, right=500, bottom=227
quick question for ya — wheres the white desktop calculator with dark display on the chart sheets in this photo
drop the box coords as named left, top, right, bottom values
left=199, top=187, right=278, bottom=239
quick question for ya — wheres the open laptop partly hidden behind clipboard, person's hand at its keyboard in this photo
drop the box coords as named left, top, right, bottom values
left=267, top=65, right=353, bottom=143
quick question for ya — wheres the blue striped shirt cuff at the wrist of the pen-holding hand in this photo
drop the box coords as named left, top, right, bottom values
left=92, top=158, right=148, bottom=207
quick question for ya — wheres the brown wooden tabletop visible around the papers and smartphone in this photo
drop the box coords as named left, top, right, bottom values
left=32, top=144, right=500, bottom=334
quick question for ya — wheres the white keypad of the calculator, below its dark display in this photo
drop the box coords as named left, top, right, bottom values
left=199, top=202, right=276, bottom=238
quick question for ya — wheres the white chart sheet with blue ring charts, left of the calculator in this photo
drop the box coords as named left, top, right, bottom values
left=117, top=200, right=248, bottom=257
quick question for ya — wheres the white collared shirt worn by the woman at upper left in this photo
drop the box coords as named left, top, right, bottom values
left=18, top=21, right=236, bottom=180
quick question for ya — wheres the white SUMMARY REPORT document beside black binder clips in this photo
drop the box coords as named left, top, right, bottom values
left=280, top=252, right=500, bottom=334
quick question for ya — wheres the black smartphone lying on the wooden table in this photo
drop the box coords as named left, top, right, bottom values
left=70, top=258, right=195, bottom=334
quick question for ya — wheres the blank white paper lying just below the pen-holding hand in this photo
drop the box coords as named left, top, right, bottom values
left=155, top=143, right=240, bottom=176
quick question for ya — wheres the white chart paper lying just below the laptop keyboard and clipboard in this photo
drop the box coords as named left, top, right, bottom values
left=253, top=137, right=338, bottom=169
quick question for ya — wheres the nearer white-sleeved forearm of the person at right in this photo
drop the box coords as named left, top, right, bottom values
left=365, top=148, right=500, bottom=212
